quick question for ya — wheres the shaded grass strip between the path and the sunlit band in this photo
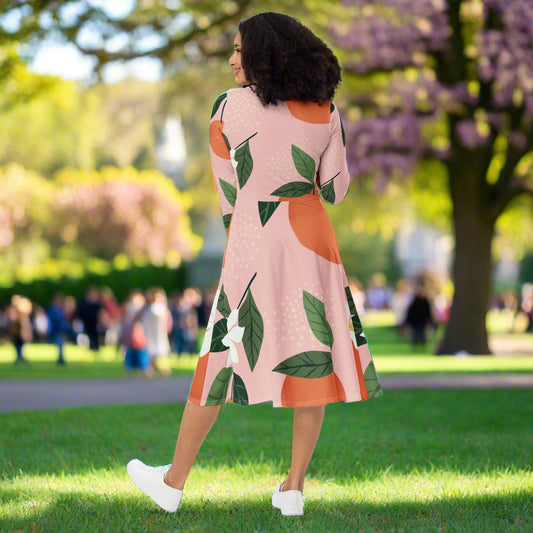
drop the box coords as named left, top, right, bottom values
left=0, top=390, right=533, bottom=483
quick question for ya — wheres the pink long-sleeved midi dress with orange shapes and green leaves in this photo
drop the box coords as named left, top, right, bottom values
left=188, top=86, right=382, bottom=407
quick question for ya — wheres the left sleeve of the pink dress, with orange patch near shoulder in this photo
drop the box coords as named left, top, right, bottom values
left=209, top=93, right=237, bottom=232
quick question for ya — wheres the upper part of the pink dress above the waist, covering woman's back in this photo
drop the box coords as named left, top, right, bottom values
left=210, top=87, right=349, bottom=207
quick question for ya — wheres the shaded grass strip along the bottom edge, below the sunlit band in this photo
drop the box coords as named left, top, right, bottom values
left=0, top=490, right=533, bottom=532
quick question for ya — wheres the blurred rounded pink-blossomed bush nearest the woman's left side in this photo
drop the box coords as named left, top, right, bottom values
left=55, top=167, right=202, bottom=264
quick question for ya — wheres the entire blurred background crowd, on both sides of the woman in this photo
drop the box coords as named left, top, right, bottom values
left=0, top=274, right=533, bottom=366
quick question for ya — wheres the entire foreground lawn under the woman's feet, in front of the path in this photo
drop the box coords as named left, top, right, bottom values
left=0, top=390, right=533, bottom=532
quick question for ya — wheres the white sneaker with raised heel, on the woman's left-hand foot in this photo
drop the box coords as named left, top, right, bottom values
left=127, top=459, right=183, bottom=513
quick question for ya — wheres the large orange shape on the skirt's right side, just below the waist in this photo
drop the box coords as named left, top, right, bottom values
left=280, top=193, right=342, bottom=265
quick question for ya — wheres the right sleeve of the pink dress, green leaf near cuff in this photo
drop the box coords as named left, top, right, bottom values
left=318, top=104, right=350, bottom=204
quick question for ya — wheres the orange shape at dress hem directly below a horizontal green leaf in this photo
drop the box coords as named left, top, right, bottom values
left=281, top=372, right=346, bottom=407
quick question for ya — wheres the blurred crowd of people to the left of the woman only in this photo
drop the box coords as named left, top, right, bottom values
left=0, top=287, right=214, bottom=375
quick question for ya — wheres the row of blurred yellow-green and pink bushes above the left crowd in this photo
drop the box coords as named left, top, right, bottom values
left=0, top=164, right=201, bottom=286
